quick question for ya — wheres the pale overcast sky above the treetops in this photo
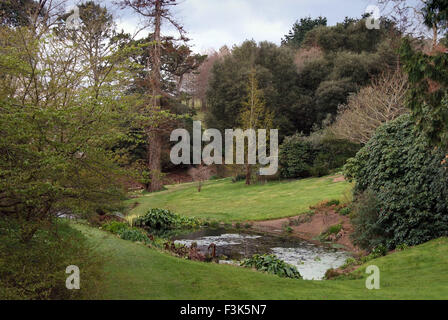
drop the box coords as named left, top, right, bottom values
left=87, top=0, right=376, bottom=52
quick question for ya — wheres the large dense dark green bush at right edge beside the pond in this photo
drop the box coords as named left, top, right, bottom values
left=345, top=115, right=448, bottom=249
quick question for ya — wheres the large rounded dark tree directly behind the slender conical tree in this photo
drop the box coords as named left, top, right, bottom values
left=205, top=41, right=302, bottom=139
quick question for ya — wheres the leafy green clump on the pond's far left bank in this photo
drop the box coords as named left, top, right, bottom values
left=132, top=208, right=201, bottom=230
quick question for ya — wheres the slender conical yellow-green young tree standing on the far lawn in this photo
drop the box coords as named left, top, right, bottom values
left=241, top=68, right=273, bottom=185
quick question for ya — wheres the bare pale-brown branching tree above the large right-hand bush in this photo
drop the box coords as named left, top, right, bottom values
left=329, top=70, right=408, bottom=144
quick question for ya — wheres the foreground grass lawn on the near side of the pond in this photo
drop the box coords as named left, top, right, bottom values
left=76, top=225, right=448, bottom=299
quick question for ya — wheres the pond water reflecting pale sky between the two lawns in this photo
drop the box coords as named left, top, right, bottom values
left=173, top=229, right=350, bottom=280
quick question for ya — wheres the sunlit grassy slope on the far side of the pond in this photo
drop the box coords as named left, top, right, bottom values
left=128, top=177, right=351, bottom=222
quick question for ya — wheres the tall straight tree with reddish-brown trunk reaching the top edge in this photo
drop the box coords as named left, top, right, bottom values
left=118, top=0, right=186, bottom=191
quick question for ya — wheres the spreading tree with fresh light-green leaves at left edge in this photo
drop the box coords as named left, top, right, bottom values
left=0, top=1, right=130, bottom=243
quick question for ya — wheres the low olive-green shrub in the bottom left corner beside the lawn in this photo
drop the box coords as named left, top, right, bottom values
left=0, top=218, right=104, bottom=300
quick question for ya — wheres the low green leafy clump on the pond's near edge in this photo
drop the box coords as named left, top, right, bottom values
left=241, top=254, right=302, bottom=279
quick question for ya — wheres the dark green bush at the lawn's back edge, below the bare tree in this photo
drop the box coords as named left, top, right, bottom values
left=279, top=134, right=359, bottom=178
